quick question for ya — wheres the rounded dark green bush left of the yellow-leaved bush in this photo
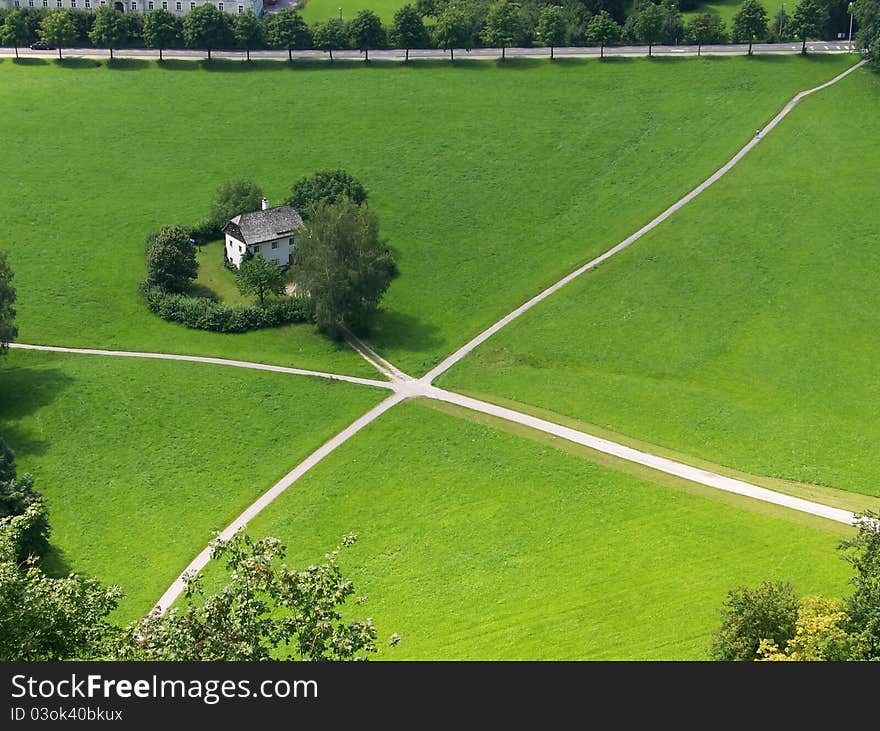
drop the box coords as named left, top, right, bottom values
left=710, top=581, right=798, bottom=661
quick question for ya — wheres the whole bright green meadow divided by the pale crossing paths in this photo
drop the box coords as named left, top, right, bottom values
left=0, top=54, right=868, bottom=659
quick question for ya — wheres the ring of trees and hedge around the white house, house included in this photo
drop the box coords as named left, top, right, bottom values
left=141, top=170, right=397, bottom=338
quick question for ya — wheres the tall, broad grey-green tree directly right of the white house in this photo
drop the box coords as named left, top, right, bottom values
left=294, top=198, right=395, bottom=337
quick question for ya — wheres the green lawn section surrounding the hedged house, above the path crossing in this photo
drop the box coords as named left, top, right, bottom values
left=0, top=57, right=851, bottom=373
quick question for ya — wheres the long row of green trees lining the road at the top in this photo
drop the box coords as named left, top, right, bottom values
left=0, top=0, right=880, bottom=61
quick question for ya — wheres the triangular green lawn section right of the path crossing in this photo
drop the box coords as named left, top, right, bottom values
left=442, top=70, right=880, bottom=495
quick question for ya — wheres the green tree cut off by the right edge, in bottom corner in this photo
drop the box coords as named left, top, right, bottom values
left=841, top=511, right=880, bottom=660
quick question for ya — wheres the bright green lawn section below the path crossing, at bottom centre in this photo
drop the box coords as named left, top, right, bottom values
left=229, top=403, right=848, bottom=660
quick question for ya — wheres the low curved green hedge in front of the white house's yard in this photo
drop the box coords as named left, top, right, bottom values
left=141, top=285, right=312, bottom=333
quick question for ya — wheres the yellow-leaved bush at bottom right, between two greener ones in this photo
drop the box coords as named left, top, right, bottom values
left=758, top=596, right=854, bottom=662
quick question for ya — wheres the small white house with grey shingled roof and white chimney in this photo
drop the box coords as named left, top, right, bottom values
left=223, top=198, right=303, bottom=267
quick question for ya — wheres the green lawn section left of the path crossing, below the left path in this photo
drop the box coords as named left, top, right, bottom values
left=0, top=350, right=384, bottom=619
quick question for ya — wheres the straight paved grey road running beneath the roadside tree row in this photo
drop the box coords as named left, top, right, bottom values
left=0, top=41, right=849, bottom=61
